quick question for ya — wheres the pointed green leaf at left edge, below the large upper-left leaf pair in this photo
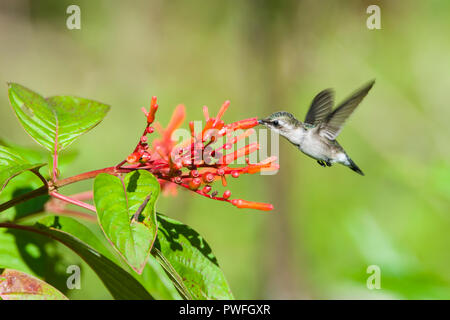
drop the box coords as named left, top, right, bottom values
left=0, top=146, right=45, bottom=192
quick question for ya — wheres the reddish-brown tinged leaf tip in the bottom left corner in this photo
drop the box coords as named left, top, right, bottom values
left=0, top=269, right=67, bottom=300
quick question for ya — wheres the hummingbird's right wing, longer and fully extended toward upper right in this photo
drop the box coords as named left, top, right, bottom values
left=319, top=80, right=375, bottom=140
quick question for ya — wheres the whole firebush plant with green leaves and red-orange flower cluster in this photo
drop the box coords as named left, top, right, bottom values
left=0, top=83, right=278, bottom=299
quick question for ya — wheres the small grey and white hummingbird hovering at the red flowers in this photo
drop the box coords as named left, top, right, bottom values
left=258, top=80, right=375, bottom=176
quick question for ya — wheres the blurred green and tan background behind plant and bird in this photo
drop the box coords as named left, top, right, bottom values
left=0, top=0, right=450, bottom=299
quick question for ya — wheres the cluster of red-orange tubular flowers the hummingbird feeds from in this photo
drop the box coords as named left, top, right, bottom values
left=118, top=97, right=278, bottom=210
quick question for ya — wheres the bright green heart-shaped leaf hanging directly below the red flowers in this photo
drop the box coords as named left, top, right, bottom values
left=94, top=170, right=160, bottom=274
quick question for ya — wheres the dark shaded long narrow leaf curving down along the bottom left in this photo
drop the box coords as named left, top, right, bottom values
left=0, top=219, right=153, bottom=300
